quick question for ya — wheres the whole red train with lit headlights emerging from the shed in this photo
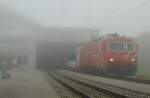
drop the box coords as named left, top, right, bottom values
left=67, top=34, right=138, bottom=75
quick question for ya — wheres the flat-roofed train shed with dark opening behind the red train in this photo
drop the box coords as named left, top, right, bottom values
left=36, top=28, right=98, bottom=69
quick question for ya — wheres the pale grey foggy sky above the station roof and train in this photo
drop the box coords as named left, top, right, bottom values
left=0, top=0, right=150, bottom=36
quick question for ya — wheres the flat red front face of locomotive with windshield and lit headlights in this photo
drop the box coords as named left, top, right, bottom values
left=105, top=37, right=138, bottom=75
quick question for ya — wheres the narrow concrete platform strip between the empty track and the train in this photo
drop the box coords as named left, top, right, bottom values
left=60, top=70, right=150, bottom=94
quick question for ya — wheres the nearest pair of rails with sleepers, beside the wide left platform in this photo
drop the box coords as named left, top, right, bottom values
left=48, top=72, right=125, bottom=98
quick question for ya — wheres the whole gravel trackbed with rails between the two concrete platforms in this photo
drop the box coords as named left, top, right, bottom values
left=47, top=72, right=150, bottom=98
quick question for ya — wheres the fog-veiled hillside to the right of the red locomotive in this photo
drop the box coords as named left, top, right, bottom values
left=137, top=32, right=150, bottom=76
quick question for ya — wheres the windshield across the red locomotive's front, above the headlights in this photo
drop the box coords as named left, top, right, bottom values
left=109, top=42, right=134, bottom=51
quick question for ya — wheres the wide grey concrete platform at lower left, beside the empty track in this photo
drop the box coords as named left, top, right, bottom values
left=0, top=69, right=58, bottom=98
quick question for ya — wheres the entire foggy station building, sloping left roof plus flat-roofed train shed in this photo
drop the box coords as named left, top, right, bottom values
left=0, top=7, right=97, bottom=69
